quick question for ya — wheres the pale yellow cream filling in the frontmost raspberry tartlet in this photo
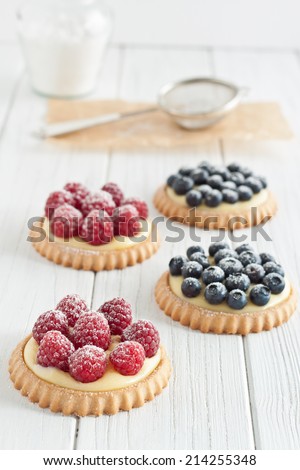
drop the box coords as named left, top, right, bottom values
left=24, top=338, right=161, bottom=392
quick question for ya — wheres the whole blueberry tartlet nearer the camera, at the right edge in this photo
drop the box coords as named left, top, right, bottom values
left=155, top=242, right=296, bottom=335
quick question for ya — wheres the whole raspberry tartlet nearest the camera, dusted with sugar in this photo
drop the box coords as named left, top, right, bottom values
left=9, top=295, right=171, bottom=416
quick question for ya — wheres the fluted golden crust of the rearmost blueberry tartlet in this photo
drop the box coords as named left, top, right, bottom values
left=153, top=185, right=277, bottom=230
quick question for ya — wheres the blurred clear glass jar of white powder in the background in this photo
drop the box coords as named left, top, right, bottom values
left=17, top=0, right=112, bottom=98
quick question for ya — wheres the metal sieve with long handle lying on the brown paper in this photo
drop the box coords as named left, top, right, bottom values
left=34, top=78, right=247, bottom=138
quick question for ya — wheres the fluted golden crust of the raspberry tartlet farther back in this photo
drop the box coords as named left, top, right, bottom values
left=29, top=220, right=159, bottom=272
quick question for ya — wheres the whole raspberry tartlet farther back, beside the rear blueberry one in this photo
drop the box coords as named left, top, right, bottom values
left=29, top=182, right=159, bottom=271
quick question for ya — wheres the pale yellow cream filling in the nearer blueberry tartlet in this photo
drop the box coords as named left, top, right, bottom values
left=169, top=275, right=291, bottom=313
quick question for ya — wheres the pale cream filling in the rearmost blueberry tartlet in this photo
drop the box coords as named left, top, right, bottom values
left=166, top=186, right=268, bottom=212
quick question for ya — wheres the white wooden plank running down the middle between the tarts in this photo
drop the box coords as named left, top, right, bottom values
left=77, top=144, right=253, bottom=449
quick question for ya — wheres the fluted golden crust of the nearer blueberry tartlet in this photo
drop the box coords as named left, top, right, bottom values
left=155, top=272, right=297, bottom=335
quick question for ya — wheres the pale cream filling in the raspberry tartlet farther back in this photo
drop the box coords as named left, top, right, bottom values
left=43, top=218, right=151, bottom=251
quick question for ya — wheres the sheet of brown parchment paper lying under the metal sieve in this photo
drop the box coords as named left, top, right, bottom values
left=47, top=100, right=293, bottom=149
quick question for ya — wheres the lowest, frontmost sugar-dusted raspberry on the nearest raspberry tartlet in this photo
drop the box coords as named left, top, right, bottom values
left=69, top=345, right=107, bottom=383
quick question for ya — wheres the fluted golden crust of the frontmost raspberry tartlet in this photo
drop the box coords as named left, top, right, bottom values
left=9, top=335, right=171, bottom=416
